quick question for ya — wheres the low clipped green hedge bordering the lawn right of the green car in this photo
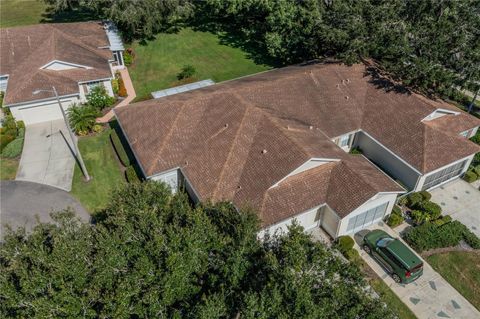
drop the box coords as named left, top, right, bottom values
left=405, top=221, right=480, bottom=252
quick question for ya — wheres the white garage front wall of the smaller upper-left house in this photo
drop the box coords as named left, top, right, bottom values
left=10, top=97, right=79, bottom=125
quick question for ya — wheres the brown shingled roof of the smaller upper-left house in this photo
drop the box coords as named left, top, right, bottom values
left=0, top=22, right=112, bottom=105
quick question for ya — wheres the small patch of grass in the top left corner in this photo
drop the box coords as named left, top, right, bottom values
left=0, top=0, right=47, bottom=28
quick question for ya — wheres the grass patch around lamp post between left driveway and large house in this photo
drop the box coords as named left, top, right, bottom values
left=71, top=129, right=125, bottom=213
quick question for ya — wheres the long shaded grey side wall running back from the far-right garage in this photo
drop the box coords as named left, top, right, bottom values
left=353, top=132, right=420, bottom=190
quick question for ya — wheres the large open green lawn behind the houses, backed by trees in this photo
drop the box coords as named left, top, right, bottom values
left=128, top=28, right=271, bottom=99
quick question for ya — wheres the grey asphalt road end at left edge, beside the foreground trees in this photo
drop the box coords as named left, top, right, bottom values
left=0, top=181, right=90, bottom=237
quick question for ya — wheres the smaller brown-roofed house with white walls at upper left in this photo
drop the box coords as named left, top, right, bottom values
left=0, top=22, right=124, bottom=125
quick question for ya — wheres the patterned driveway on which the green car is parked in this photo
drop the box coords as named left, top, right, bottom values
left=355, top=223, right=480, bottom=319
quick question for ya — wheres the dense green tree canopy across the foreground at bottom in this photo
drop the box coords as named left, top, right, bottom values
left=0, top=182, right=392, bottom=319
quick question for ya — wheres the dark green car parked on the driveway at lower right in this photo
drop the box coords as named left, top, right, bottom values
left=363, top=229, right=423, bottom=284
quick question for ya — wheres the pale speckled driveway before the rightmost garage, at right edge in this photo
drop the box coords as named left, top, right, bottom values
left=430, top=179, right=480, bottom=237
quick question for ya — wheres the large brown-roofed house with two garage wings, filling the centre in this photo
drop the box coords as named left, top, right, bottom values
left=115, top=64, right=480, bottom=238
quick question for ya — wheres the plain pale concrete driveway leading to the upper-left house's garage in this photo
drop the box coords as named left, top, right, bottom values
left=16, top=120, right=75, bottom=191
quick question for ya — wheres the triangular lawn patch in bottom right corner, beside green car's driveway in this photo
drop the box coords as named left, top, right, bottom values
left=427, top=251, right=480, bottom=310
